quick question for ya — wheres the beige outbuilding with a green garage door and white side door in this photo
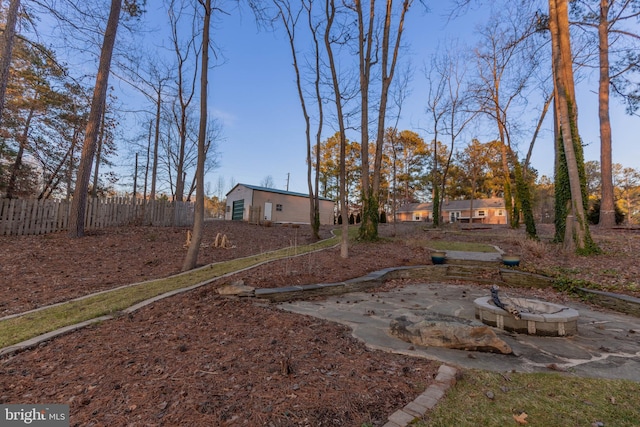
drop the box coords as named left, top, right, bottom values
left=224, top=184, right=335, bottom=225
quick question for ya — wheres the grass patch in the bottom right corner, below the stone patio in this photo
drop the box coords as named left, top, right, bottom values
left=420, top=370, right=640, bottom=427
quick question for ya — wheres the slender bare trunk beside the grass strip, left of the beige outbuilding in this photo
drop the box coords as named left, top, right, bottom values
left=182, top=0, right=211, bottom=271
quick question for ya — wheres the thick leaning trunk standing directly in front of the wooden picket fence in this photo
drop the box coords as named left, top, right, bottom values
left=68, top=0, right=122, bottom=237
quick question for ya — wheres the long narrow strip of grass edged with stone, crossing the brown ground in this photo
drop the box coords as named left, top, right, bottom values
left=0, top=231, right=340, bottom=348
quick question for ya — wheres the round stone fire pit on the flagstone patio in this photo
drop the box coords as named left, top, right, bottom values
left=474, top=296, right=579, bottom=337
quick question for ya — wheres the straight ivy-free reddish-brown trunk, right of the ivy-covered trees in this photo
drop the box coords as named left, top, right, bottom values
left=598, top=0, right=616, bottom=228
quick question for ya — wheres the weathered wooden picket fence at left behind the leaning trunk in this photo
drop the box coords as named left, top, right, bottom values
left=0, top=198, right=193, bottom=236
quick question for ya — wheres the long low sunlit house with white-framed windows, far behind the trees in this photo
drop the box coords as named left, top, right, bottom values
left=396, top=197, right=507, bottom=224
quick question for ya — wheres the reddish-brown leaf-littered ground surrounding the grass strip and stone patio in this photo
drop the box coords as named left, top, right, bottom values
left=0, top=221, right=640, bottom=426
